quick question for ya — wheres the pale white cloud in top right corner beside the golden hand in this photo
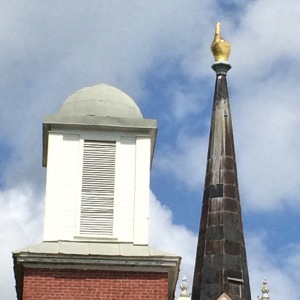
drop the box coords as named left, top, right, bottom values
left=231, top=0, right=300, bottom=79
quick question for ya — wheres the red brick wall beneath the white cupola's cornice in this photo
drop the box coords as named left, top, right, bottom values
left=23, top=269, right=168, bottom=300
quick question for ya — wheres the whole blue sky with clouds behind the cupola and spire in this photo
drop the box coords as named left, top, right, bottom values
left=0, top=0, right=300, bottom=300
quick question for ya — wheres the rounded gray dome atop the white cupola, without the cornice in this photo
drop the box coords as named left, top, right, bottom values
left=58, top=83, right=143, bottom=119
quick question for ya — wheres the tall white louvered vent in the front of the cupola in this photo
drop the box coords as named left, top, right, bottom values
left=80, top=141, right=116, bottom=236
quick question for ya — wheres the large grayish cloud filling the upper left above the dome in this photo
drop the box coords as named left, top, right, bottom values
left=0, top=0, right=214, bottom=192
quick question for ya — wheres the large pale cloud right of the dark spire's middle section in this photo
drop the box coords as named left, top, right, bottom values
left=232, top=68, right=300, bottom=209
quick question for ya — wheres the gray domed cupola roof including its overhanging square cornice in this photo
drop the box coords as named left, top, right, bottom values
left=43, top=83, right=157, bottom=167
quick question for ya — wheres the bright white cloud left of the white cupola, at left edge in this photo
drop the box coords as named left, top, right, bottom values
left=0, top=187, right=44, bottom=300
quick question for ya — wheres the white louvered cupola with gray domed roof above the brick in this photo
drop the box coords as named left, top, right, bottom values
left=43, top=84, right=157, bottom=245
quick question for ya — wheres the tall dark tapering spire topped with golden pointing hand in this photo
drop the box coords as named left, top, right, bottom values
left=192, top=23, right=251, bottom=300
